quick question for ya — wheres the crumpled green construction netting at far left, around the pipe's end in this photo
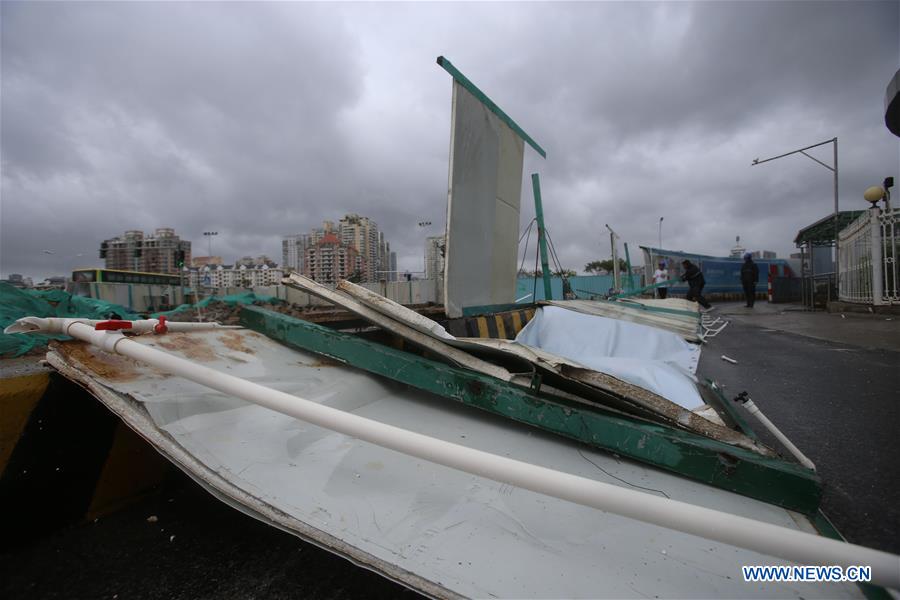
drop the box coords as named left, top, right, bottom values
left=0, top=283, right=141, bottom=357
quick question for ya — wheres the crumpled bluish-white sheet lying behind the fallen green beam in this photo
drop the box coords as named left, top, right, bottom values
left=516, top=306, right=704, bottom=410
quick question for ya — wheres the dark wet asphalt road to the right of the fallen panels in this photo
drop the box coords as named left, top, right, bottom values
left=698, top=312, right=900, bottom=553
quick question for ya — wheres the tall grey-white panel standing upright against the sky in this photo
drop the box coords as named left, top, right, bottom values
left=444, top=80, right=524, bottom=317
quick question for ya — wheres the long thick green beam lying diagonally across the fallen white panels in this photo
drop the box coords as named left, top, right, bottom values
left=241, top=306, right=822, bottom=514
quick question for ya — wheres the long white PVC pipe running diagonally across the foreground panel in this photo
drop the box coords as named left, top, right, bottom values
left=8, top=319, right=900, bottom=589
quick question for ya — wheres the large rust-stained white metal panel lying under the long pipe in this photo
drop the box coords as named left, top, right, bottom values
left=51, top=331, right=860, bottom=598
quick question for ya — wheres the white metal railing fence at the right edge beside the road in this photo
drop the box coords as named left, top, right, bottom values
left=838, top=208, right=900, bottom=305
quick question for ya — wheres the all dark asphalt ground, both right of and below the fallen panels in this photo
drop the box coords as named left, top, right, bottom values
left=0, top=308, right=900, bottom=599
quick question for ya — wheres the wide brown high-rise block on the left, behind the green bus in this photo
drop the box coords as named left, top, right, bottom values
left=100, top=227, right=191, bottom=273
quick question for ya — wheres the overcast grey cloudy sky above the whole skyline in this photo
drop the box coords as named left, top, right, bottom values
left=0, top=1, right=900, bottom=279
